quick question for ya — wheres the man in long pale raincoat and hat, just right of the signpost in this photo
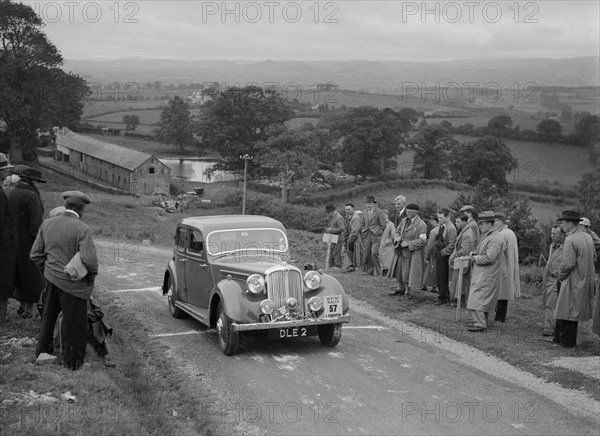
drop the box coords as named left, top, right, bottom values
left=467, top=211, right=503, bottom=332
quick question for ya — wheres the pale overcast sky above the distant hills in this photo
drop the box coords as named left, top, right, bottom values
left=23, top=0, right=600, bottom=61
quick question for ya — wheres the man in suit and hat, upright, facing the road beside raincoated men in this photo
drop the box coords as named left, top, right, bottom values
left=360, top=195, right=386, bottom=275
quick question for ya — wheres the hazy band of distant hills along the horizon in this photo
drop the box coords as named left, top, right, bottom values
left=64, top=57, right=600, bottom=92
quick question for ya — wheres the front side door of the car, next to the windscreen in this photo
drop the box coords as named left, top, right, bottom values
left=185, top=227, right=213, bottom=308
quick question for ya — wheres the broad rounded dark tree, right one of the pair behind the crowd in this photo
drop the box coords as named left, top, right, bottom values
left=448, top=136, right=517, bottom=186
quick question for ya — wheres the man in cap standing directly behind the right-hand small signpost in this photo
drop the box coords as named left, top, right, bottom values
left=448, top=215, right=475, bottom=306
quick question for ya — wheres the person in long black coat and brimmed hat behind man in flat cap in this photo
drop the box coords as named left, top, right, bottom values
left=6, top=165, right=46, bottom=318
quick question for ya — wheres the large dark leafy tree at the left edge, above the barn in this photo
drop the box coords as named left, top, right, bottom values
left=0, top=2, right=90, bottom=162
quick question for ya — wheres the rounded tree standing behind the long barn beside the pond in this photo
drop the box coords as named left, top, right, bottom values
left=155, top=97, right=194, bottom=153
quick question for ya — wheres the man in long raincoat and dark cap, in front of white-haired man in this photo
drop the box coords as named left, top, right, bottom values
left=388, top=203, right=427, bottom=299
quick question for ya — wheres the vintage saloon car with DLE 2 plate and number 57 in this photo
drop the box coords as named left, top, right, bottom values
left=162, top=215, right=350, bottom=356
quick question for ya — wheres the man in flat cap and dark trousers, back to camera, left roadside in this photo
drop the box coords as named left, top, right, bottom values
left=31, top=191, right=98, bottom=370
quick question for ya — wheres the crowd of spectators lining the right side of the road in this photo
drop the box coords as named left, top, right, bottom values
left=325, top=195, right=600, bottom=347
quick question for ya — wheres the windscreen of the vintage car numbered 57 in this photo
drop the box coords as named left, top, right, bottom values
left=206, top=228, right=288, bottom=256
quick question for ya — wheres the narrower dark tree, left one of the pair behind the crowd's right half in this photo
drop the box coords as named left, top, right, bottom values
left=409, top=124, right=456, bottom=179
